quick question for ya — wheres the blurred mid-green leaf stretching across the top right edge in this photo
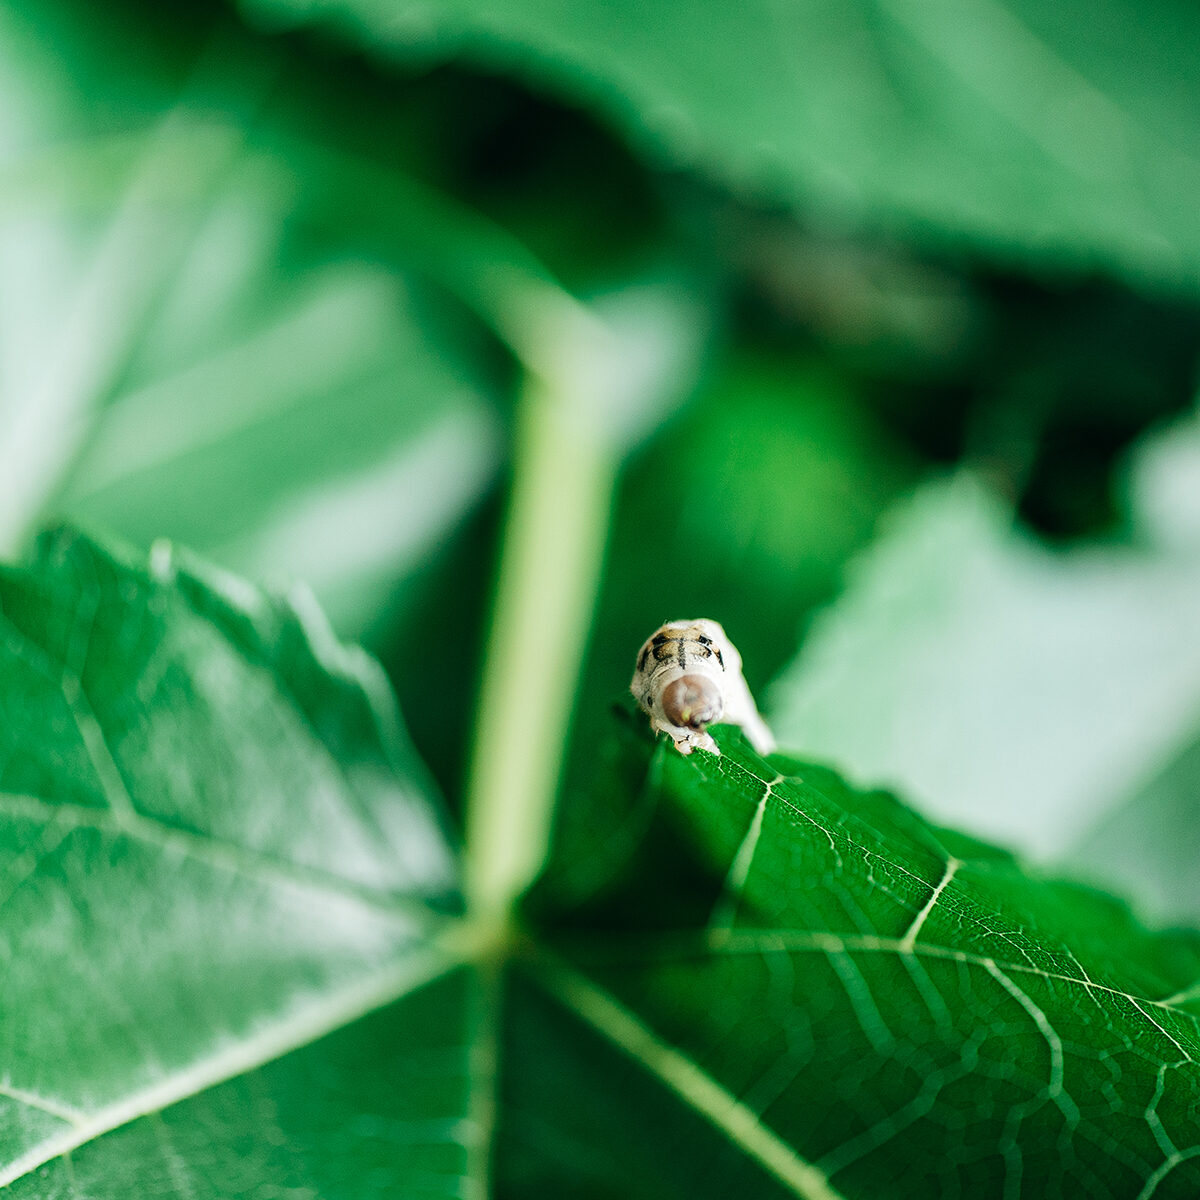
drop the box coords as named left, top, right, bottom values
left=238, top=0, right=1200, bottom=288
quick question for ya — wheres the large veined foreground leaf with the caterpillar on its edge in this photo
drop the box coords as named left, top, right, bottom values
left=0, top=533, right=1200, bottom=1200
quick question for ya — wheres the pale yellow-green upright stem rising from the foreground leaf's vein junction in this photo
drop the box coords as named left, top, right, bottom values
left=467, top=372, right=616, bottom=929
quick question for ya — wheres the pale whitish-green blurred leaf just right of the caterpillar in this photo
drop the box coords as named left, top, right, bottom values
left=772, top=475, right=1200, bottom=858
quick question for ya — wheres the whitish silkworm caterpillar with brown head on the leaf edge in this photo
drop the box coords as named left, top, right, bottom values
left=629, top=618, right=775, bottom=755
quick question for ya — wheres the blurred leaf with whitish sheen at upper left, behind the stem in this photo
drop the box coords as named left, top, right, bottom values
left=0, top=0, right=502, bottom=635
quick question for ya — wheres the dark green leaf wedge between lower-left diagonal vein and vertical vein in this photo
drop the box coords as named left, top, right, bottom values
left=4, top=971, right=478, bottom=1200
